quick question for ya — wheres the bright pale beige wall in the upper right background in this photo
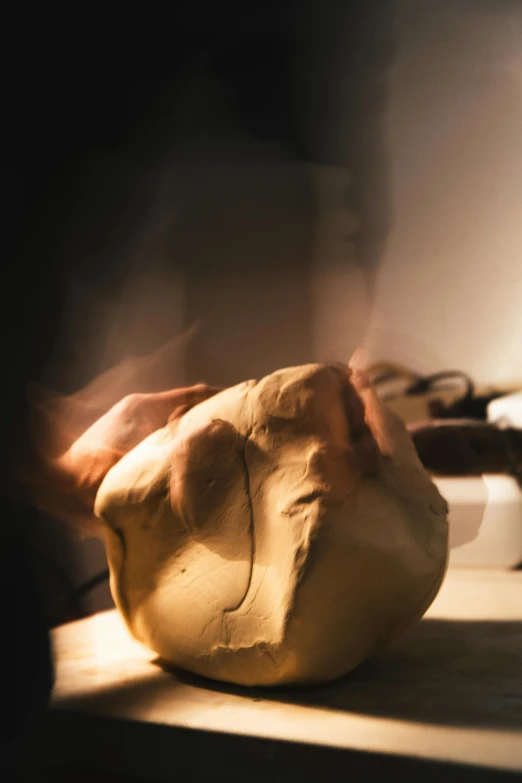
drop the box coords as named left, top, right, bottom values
left=358, top=0, right=522, bottom=383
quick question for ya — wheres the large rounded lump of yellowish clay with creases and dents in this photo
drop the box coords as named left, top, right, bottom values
left=96, top=365, right=448, bottom=685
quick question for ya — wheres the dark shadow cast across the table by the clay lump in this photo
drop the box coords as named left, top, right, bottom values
left=167, top=620, right=522, bottom=729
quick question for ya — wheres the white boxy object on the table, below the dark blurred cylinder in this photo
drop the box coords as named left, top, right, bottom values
left=433, top=475, right=522, bottom=569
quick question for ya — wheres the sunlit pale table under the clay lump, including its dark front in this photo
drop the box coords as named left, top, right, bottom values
left=23, top=571, right=522, bottom=781
